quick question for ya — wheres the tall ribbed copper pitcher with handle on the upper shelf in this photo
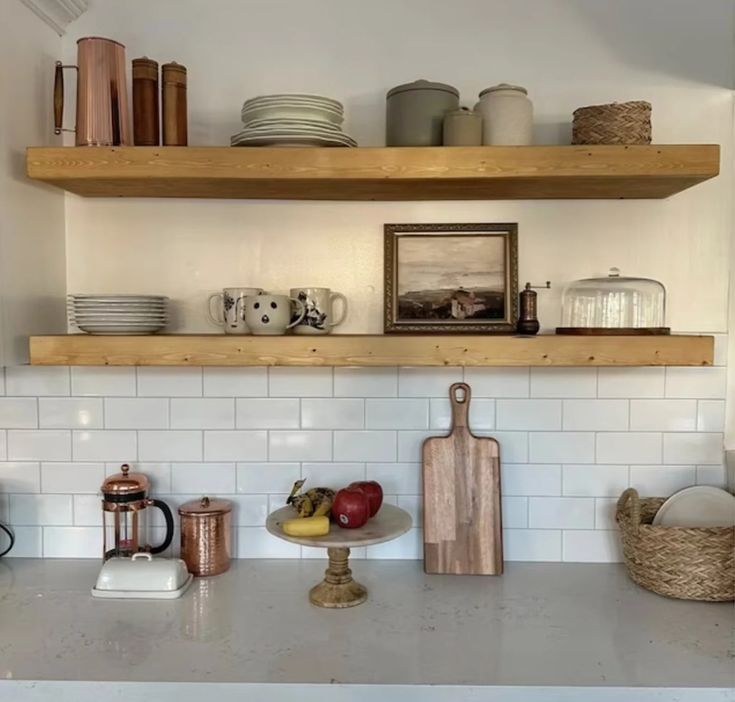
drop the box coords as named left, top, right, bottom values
left=54, top=37, right=133, bottom=146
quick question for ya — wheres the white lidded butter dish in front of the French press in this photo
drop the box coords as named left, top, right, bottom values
left=92, top=553, right=193, bottom=600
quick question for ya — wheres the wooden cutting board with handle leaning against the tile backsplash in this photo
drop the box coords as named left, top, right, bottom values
left=423, top=383, right=503, bottom=575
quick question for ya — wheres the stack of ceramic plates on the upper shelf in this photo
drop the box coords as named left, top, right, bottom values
left=230, top=93, right=357, bottom=146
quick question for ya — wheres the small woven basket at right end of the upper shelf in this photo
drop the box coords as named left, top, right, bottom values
left=572, top=100, right=651, bottom=144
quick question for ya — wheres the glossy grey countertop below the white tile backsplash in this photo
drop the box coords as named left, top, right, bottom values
left=0, top=559, right=735, bottom=702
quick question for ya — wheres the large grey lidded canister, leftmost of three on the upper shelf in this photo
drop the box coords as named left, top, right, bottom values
left=385, top=80, right=459, bottom=146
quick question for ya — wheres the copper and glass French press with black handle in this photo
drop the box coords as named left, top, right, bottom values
left=101, top=463, right=174, bottom=560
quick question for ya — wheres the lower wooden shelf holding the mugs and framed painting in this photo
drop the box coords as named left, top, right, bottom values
left=30, top=334, right=714, bottom=366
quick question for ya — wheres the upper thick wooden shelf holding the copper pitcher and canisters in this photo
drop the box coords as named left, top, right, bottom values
left=27, top=144, right=720, bottom=200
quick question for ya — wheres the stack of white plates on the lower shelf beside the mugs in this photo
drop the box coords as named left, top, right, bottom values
left=68, top=295, right=168, bottom=334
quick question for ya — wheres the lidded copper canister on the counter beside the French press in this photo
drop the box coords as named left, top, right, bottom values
left=179, top=496, right=232, bottom=576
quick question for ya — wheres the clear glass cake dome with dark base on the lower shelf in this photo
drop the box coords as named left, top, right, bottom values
left=556, top=268, right=670, bottom=334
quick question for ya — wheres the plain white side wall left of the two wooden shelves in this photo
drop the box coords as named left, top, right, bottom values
left=0, top=0, right=66, bottom=364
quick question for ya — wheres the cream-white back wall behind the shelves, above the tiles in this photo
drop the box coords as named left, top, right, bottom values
left=64, top=0, right=733, bottom=332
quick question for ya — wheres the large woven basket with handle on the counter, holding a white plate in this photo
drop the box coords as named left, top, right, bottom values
left=615, top=488, right=735, bottom=602
